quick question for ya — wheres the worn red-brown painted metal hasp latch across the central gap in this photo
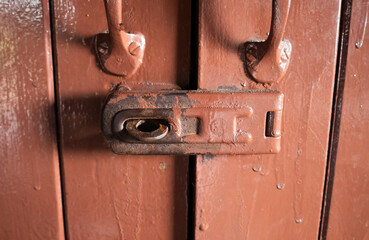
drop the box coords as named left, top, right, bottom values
left=102, top=90, right=283, bottom=155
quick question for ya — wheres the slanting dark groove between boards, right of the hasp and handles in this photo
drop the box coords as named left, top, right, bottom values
left=319, top=0, right=352, bottom=240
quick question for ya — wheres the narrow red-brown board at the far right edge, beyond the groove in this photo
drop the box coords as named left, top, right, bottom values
left=327, top=1, right=369, bottom=239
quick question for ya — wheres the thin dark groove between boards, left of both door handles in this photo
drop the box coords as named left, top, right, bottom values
left=49, top=0, right=69, bottom=240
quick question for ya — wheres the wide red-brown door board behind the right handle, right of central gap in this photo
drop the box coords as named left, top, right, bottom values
left=195, top=0, right=340, bottom=239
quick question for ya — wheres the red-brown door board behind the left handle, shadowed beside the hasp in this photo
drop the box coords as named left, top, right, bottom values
left=54, top=0, right=191, bottom=239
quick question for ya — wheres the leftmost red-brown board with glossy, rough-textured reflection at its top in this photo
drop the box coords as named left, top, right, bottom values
left=0, top=0, right=64, bottom=240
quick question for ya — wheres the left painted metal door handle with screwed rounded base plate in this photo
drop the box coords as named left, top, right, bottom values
left=95, top=0, right=145, bottom=77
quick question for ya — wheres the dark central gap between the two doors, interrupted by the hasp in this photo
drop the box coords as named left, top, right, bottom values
left=187, top=0, right=199, bottom=240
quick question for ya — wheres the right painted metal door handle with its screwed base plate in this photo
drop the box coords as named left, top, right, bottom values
left=245, top=0, right=292, bottom=83
